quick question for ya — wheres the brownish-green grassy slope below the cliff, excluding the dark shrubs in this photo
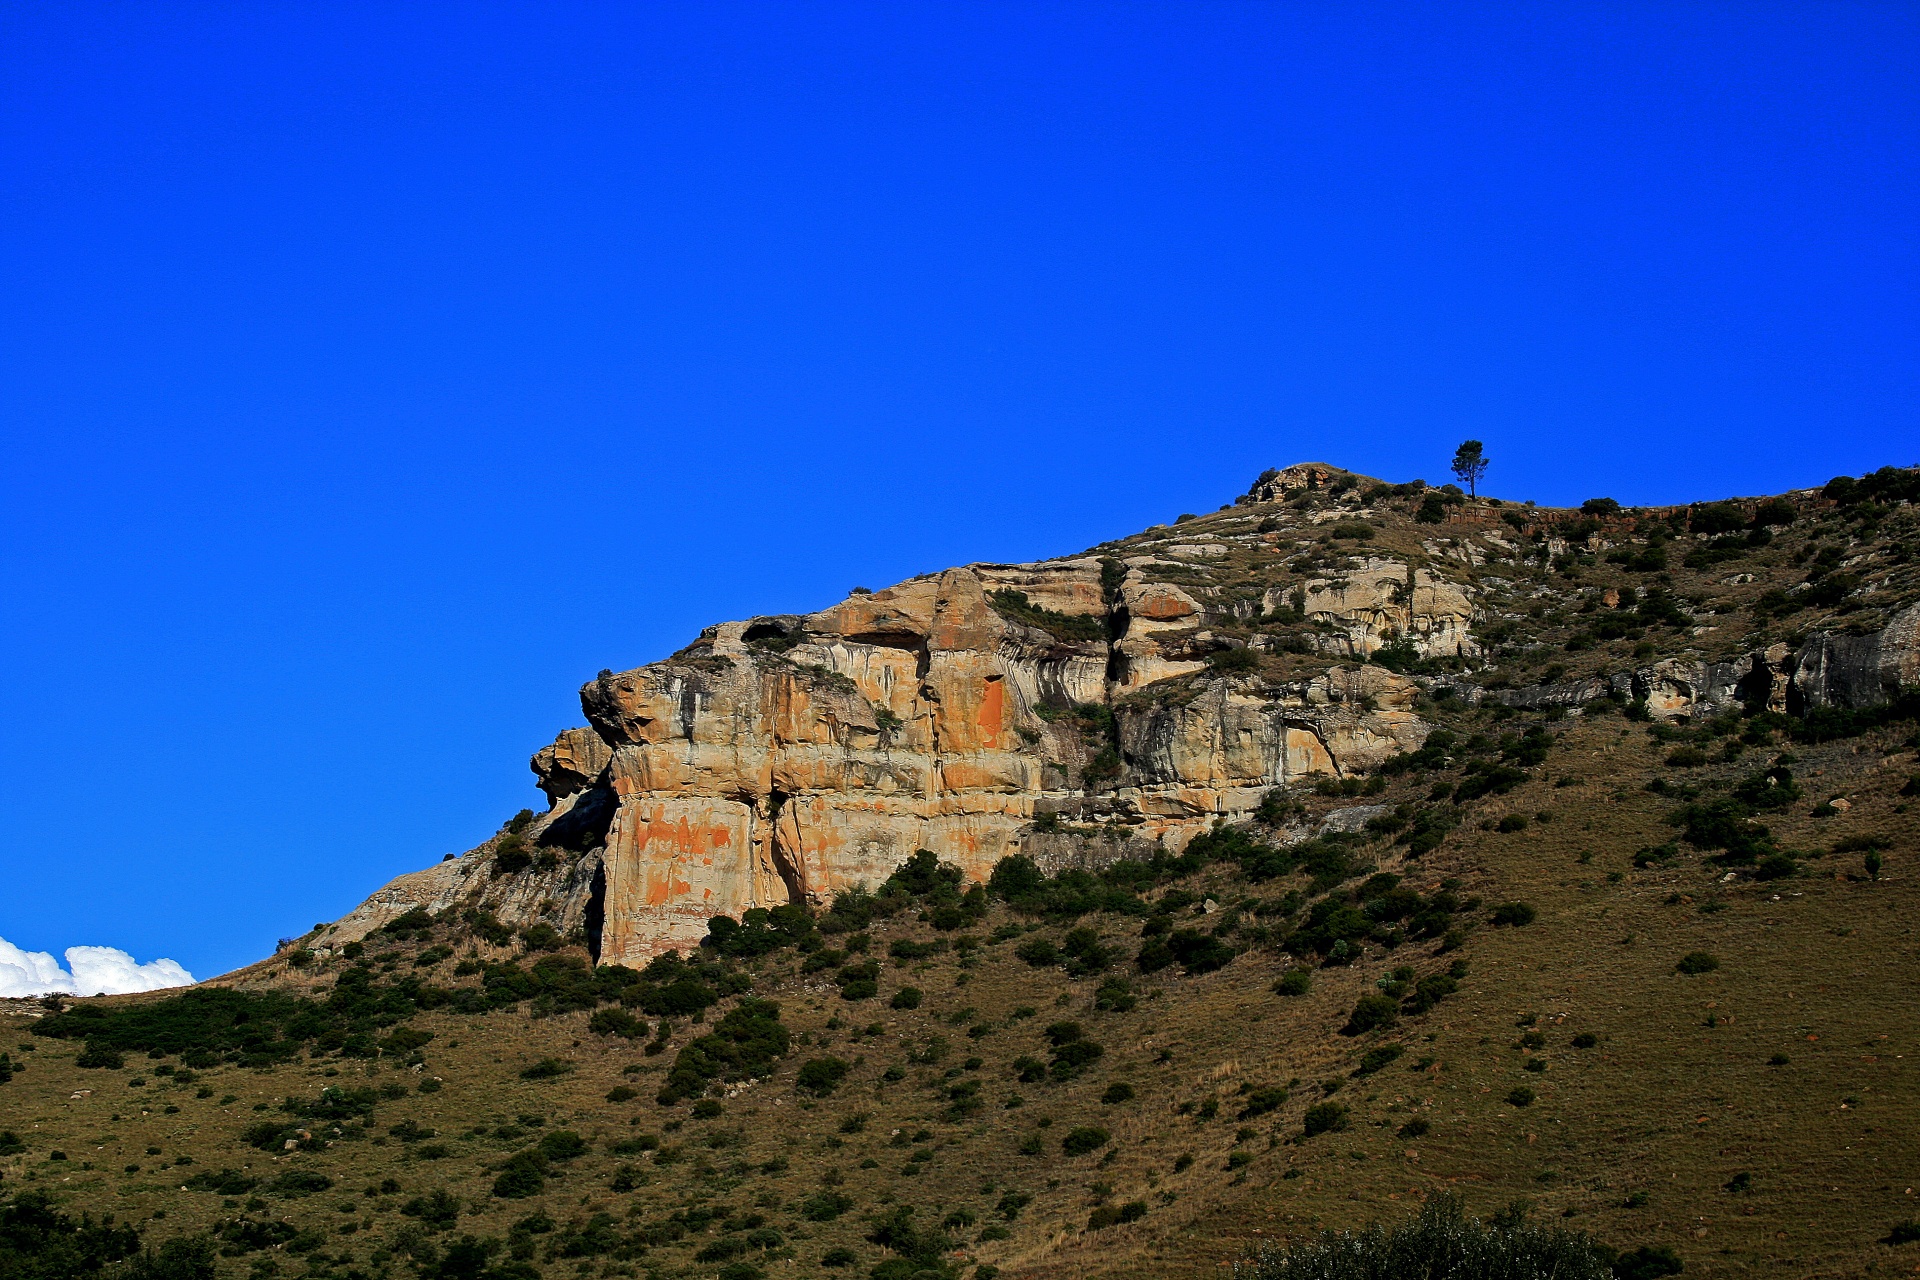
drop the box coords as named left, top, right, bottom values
left=0, top=475, right=1920, bottom=1276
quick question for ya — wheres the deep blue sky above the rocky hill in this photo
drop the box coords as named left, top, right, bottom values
left=0, top=0, right=1920, bottom=975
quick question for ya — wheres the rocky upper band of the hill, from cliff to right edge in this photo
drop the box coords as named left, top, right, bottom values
left=313, top=462, right=1920, bottom=961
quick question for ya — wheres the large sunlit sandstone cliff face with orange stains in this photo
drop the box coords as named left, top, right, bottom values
left=534, top=558, right=1423, bottom=960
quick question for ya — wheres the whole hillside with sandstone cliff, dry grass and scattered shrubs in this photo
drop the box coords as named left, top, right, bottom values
left=0, top=464, right=1920, bottom=1280
